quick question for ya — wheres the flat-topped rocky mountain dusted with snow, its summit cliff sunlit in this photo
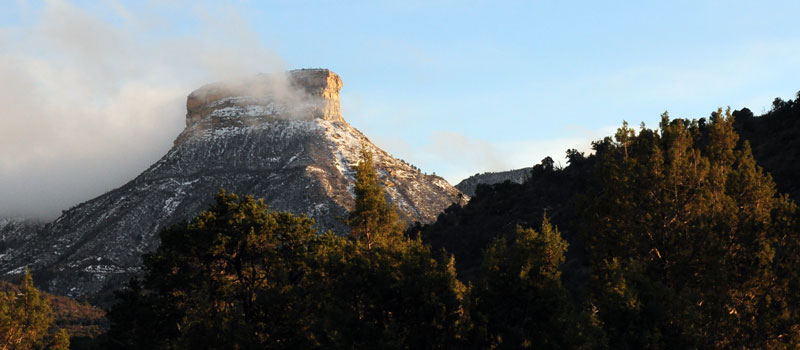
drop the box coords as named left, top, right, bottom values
left=0, top=69, right=467, bottom=301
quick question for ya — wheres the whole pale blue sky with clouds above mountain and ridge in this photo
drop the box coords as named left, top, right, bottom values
left=0, top=0, right=800, bottom=214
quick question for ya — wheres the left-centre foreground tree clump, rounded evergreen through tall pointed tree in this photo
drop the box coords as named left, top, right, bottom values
left=108, top=152, right=465, bottom=349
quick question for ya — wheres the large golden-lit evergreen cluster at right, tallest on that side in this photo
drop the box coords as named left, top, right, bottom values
left=582, top=110, right=797, bottom=349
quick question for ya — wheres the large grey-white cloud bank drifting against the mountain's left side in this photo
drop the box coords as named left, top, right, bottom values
left=0, top=0, right=284, bottom=218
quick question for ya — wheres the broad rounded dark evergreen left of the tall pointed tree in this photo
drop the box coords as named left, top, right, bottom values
left=109, top=191, right=317, bottom=349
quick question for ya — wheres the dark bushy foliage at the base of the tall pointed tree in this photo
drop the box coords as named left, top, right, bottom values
left=311, top=236, right=464, bottom=349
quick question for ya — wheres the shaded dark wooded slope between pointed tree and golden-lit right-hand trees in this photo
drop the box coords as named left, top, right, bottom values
left=418, top=151, right=593, bottom=280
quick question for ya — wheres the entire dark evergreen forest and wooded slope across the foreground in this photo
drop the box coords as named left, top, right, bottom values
left=0, top=94, right=800, bottom=349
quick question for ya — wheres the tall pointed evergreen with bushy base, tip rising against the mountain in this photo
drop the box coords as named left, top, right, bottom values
left=310, top=148, right=465, bottom=349
